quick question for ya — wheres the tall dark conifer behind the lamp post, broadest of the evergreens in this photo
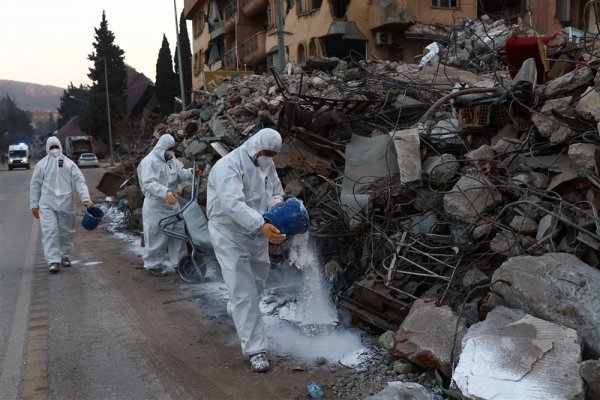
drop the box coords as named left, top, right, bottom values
left=81, top=11, right=127, bottom=144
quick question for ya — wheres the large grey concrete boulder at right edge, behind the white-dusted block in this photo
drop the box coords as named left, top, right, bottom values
left=492, top=253, right=600, bottom=357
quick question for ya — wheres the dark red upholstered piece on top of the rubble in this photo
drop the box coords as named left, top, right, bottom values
left=504, top=33, right=554, bottom=83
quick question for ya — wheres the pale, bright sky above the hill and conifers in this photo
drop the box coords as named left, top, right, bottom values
left=0, top=0, right=192, bottom=88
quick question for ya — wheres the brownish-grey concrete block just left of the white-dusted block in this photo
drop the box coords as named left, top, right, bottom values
left=393, top=300, right=466, bottom=376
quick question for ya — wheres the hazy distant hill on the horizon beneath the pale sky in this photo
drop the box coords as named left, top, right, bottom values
left=0, top=79, right=65, bottom=111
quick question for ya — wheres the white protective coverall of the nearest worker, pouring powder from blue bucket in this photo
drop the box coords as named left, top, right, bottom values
left=207, top=129, right=284, bottom=356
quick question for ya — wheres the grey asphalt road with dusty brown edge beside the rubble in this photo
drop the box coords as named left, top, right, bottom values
left=0, top=160, right=344, bottom=400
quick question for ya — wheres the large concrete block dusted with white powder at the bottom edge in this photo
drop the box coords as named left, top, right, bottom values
left=452, top=307, right=584, bottom=400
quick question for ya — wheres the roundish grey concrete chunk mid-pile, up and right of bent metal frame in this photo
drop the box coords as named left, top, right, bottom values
left=444, top=174, right=502, bottom=222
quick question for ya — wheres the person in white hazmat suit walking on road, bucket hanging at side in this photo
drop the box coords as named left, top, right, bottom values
left=29, top=136, right=94, bottom=273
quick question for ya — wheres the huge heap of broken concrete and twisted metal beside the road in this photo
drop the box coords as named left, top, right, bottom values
left=102, top=22, right=600, bottom=399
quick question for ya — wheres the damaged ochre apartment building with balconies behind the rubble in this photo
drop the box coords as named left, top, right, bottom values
left=184, top=0, right=597, bottom=90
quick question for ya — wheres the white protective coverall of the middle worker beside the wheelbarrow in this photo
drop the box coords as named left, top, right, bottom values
left=137, top=134, right=192, bottom=269
